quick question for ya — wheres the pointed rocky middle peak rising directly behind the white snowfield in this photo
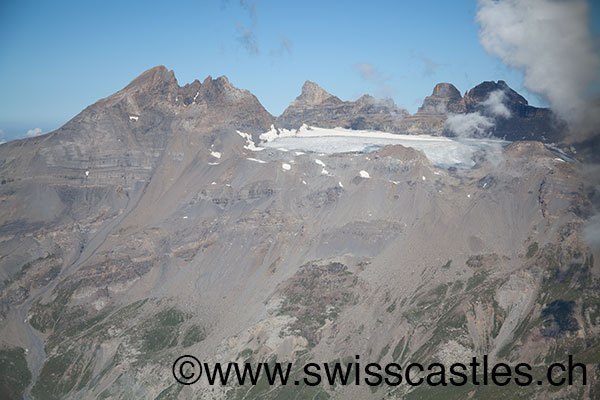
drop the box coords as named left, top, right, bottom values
left=276, top=81, right=409, bottom=133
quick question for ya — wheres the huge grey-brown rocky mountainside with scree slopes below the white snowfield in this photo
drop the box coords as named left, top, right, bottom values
left=0, top=67, right=600, bottom=399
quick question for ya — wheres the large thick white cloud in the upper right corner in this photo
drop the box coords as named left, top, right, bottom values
left=476, top=0, right=600, bottom=130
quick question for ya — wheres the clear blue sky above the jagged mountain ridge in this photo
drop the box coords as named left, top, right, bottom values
left=0, top=0, right=600, bottom=140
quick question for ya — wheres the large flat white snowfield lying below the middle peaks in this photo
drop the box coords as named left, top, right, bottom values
left=259, top=125, right=509, bottom=168
